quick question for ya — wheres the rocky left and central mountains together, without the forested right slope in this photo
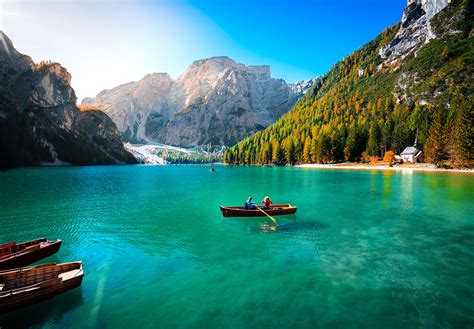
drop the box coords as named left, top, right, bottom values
left=0, top=32, right=314, bottom=168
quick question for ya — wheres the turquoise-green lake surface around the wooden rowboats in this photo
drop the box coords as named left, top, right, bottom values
left=0, top=166, right=474, bottom=329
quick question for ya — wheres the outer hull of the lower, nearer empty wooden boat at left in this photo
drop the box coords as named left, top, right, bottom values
left=0, top=262, right=84, bottom=314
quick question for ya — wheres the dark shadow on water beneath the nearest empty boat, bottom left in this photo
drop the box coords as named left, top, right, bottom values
left=0, top=287, right=84, bottom=328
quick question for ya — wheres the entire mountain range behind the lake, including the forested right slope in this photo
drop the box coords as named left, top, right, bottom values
left=0, top=0, right=474, bottom=168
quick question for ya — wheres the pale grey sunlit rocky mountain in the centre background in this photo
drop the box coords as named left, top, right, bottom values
left=83, top=57, right=312, bottom=146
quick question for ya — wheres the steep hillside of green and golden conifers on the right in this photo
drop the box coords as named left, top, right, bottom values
left=224, top=0, right=474, bottom=166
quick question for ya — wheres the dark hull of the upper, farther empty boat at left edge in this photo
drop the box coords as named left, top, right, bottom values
left=0, top=239, right=62, bottom=271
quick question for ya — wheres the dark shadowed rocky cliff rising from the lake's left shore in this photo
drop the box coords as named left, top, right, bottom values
left=0, top=32, right=136, bottom=168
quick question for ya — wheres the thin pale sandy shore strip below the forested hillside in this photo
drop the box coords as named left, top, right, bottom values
left=295, top=163, right=474, bottom=174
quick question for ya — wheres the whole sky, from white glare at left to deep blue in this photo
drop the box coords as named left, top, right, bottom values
left=0, top=0, right=406, bottom=101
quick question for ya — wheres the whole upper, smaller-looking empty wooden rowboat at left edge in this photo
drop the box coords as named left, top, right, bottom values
left=0, top=238, right=61, bottom=271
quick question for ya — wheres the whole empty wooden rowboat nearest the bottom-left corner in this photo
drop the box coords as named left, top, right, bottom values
left=0, top=262, right=84, bottom=313
